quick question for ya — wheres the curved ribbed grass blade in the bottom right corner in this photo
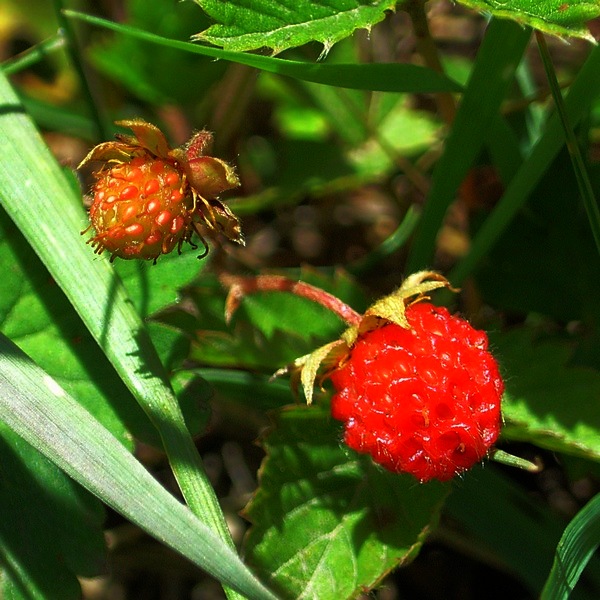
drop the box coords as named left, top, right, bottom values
left=541, top=494, right=600, bottom=600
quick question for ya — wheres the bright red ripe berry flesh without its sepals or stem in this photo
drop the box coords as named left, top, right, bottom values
left=330, top=302, right=504, bottom=481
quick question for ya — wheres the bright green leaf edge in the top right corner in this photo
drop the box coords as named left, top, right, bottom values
left=458, top=0, right=600, bottom=42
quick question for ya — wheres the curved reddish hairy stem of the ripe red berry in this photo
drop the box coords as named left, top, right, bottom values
left=221, top=275, right=362, bottom=326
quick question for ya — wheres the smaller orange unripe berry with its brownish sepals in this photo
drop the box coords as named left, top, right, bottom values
left=79, top=119, right=243, bottom=261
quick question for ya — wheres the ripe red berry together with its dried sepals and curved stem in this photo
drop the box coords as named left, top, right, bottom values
left=224, top=271, right=502, bottom=482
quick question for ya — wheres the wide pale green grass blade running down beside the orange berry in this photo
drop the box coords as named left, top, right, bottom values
left=0, top=63, right=245, bottom=596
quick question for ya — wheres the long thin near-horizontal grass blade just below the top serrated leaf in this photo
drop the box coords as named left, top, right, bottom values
left=64, top=10, right=462, bottom=93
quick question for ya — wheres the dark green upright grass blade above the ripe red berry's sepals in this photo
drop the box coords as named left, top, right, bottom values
left=407, top=19, right=530, bottom=273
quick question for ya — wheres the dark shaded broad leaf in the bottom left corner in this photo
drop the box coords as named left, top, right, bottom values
left=0, top=423, right=106, bottom=600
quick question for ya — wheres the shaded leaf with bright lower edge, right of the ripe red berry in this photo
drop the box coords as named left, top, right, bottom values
left=490, top=329, right=600, bottom=461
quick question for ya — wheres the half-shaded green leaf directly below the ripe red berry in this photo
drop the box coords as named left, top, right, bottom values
left=246, top=406, right=449, bottom=600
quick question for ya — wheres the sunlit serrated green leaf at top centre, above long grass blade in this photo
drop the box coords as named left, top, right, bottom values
left=193, top=0, right=396, bottom=54
